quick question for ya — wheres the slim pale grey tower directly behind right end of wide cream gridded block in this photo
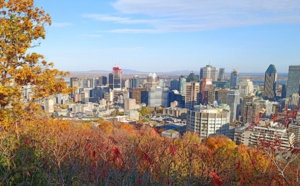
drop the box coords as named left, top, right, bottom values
left=227, top=90, right=240, bottom=122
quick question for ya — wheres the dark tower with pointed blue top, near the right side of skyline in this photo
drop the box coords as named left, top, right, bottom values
left=264, top=64, right=277, bottom=100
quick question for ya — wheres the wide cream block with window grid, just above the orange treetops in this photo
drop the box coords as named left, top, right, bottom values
left=187, top=106, right=230, bottom=139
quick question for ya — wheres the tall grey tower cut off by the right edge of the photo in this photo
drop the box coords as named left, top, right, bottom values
left=286, top=65, right=300, bottom=97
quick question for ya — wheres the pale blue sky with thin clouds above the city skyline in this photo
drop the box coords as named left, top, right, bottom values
left=34, top=0, right=300, bottom=72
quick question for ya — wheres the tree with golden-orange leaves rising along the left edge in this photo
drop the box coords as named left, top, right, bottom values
left=0, top=0, right=68, bottom=125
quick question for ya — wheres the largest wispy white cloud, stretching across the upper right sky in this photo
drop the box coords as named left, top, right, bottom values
left=109, top=0, right=300, bottom=33
